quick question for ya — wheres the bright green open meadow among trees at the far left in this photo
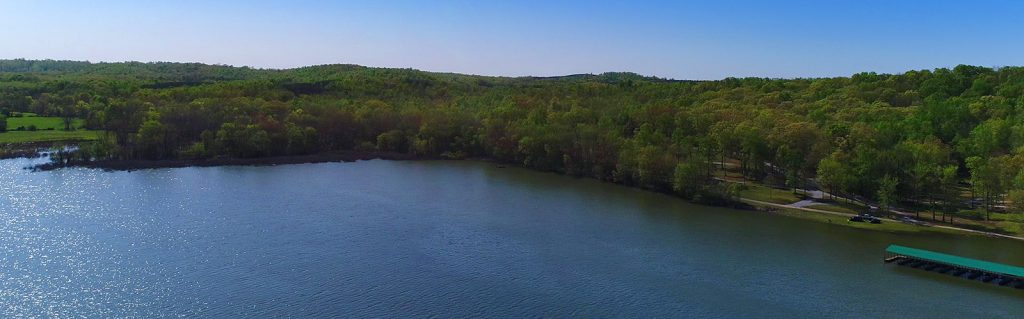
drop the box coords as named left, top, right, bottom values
left=0, top=117, right=102, bottom=144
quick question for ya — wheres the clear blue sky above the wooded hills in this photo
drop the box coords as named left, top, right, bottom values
left=0, top=0, right=1024, bottom=80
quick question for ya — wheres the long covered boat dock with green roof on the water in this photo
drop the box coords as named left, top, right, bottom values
left=885, top=244, right=1024, bottom=288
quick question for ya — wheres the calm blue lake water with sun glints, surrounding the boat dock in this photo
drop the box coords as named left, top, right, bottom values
left=0, top=160, right=1024, bottom=318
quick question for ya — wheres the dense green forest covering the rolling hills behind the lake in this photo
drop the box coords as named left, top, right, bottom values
left=0, top=60, right=1024, bottom=218
